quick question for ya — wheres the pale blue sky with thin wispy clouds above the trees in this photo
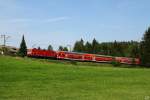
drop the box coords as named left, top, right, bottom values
left=0, top=0, right=150, bottom=50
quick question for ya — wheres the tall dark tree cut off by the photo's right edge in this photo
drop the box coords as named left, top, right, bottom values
left=140, top=27, right=150, bottom=67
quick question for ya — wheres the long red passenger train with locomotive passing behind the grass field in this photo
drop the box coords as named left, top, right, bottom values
left=27, top=48, right=140, bottom=65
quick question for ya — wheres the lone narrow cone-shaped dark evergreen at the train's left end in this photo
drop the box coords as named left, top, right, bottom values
left=18, top=35, right=27, bottom=57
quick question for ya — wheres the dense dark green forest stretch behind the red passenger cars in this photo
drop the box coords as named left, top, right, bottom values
left=73, top=38, right=140, bottom=57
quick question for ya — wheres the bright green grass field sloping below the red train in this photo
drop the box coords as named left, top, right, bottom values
left=0, top=56, right=150, bottom=100
